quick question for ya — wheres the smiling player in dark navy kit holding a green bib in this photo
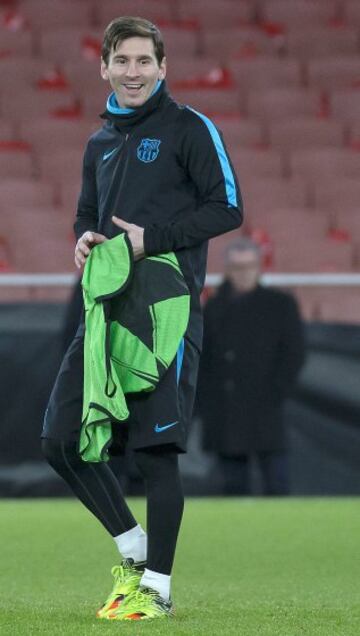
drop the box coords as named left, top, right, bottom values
left=42, top=17, right=242, bottom=620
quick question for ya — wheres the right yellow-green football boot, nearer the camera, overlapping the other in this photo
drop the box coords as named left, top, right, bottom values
left=106, top=587, right=174, bottom=621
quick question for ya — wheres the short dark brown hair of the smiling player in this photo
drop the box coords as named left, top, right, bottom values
left=101, top=16, right=165, bottom=66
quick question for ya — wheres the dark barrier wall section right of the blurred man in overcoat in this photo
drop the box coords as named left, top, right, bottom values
left=287, top=323, right=360, bottom=494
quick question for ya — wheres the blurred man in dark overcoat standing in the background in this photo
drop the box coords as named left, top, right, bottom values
left=198, top=238, right=304, bottom=495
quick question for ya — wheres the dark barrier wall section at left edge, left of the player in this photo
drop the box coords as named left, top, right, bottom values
left=0, top=304, right=64, bottom=466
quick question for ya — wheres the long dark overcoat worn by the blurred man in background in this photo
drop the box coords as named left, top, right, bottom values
left=198, top=281, right=304, bottom=456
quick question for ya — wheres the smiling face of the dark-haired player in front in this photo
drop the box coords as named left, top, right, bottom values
left=101, top=37, right=166, bottom=108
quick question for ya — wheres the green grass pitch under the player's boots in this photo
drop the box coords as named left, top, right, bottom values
left=0, top=498, right=360, bottom=636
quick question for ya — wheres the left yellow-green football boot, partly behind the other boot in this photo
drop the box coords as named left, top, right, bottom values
left=96, top=559, right=145, bottom=618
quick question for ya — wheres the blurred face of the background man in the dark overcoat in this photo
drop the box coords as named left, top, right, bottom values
left=226, top=249, right=260, bottom=292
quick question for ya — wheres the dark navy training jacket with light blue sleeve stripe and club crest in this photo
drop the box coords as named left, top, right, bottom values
left=74, top=82, right=242, bottom=349
